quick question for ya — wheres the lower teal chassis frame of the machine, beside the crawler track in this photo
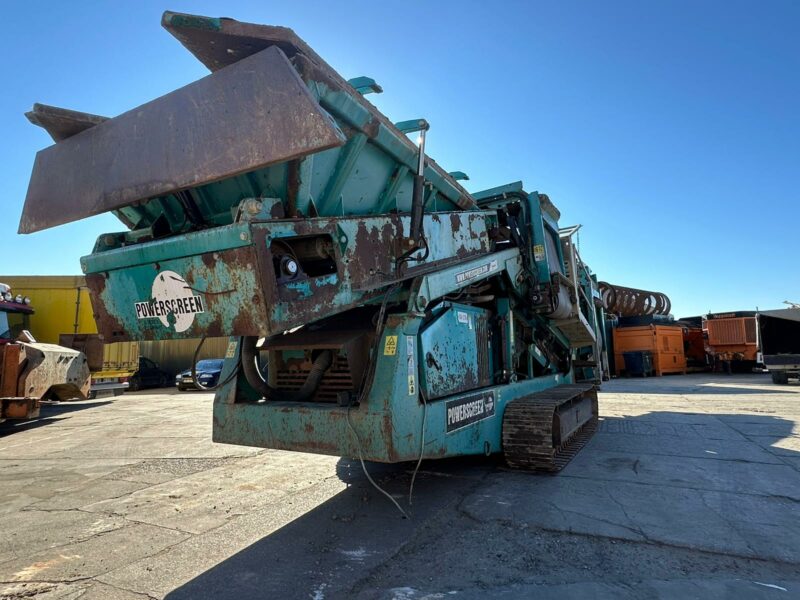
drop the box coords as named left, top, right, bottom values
left=213, top=314, right=573, bottom=462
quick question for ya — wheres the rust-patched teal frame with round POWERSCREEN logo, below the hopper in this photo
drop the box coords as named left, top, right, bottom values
left=82, top=211, right=496, bottom=341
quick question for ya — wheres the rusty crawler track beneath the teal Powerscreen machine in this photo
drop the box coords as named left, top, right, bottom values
left=503, top=384, right=598, bottom=473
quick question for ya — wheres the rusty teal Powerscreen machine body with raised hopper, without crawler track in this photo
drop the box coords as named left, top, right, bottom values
left=20, top=13, right=602, bottom=462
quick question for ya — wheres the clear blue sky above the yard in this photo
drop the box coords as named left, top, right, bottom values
left=0, top=0, right=800, bottom=317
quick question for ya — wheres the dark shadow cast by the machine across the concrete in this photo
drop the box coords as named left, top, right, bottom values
left=161, top=406, right=800, bottom=600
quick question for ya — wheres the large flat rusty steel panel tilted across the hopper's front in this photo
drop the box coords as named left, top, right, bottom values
left=19, top=47, right=345, bottom=233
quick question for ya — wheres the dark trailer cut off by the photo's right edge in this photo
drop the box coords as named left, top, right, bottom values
left=758, top=308, right=800, bottom=384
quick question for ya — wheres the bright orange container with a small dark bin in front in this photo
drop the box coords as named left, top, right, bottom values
left=614, top=325, right=686, bottom=376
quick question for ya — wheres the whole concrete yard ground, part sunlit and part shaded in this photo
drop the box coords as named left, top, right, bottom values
left=0, top=374, right=800, bottom=600
